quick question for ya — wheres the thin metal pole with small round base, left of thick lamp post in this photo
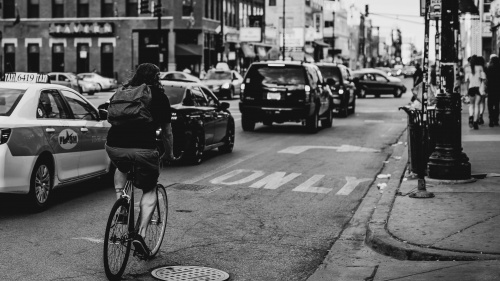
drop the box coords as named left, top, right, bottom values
left=410, top=0, right=434, bottom=198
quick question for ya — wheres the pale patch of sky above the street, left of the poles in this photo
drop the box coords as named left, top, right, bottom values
left=347, top=0, right=424, bottom=50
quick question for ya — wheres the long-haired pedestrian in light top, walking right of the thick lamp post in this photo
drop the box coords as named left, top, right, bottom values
left=465, top=56, right=486, bottom=130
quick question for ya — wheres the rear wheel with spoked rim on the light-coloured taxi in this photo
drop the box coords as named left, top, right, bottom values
left=28, top=160, right=54, bottom=211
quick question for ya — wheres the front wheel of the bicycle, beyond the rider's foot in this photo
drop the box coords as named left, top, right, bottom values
left=145, top=184, right=168, bottom=257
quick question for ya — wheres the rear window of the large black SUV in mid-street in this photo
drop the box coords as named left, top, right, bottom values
left=245, top=65, right=306, bottom=86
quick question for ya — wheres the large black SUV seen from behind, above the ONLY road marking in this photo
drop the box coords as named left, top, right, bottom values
left=240, top=61, right=333, bottom=133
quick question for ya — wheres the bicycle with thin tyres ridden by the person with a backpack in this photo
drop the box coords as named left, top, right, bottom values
left=103, top=165, right=168, bottom=280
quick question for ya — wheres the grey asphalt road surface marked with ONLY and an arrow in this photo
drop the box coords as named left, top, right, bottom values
left=0, top=77, right=411, bottom=281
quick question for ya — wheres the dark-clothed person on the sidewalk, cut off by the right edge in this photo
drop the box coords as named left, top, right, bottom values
left=486, top=54, right=500, bottom=127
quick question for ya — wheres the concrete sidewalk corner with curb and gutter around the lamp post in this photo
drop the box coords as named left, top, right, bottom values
left=308, top=109, right=500, bottom=281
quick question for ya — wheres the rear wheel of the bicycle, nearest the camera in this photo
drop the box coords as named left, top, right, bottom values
left=103, top=199, right=132, bottom=280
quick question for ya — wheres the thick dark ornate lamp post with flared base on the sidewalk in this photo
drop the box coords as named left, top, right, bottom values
left=424, top=0, right=471, bottom=181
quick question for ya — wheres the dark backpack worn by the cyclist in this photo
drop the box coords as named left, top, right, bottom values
left=108, top=84, right=153, bottom=126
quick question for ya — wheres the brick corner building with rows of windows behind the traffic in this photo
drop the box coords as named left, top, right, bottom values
left=0, top=0, right=264, bottom=82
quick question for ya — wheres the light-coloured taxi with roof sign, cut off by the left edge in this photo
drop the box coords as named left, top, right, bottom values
left=0, top=72, right=110, bottom=210
